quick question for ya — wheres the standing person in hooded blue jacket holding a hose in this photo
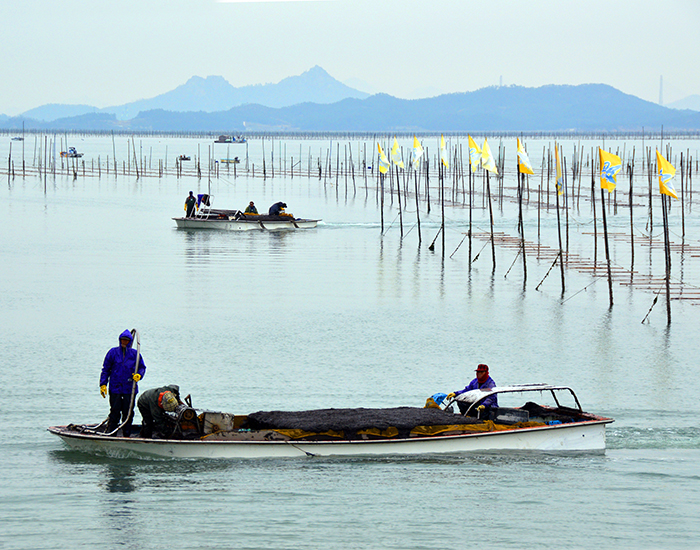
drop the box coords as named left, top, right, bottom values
left=100, top=330, right=146, bottom=437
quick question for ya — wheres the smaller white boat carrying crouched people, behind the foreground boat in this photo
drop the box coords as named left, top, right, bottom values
left=173, top=194, right=321, bottom=231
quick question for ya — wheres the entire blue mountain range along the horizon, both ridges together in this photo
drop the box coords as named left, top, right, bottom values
left=0, top=67, right=700, bottom=134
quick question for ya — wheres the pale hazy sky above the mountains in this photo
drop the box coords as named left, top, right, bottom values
left=0, top=0, right=700, bottom=115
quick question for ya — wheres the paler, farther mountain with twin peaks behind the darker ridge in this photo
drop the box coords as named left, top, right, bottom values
left=17, top=66, right=369, bottom=122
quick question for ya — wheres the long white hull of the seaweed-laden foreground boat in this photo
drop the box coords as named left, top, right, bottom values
left=49, top=419, right=612, bottom=458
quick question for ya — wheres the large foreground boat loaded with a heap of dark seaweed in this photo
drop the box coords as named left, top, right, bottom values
left=48, top=384, right=613, bottom=459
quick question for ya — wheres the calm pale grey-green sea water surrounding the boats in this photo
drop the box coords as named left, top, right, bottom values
left=0, top=137, right=700, bottom=549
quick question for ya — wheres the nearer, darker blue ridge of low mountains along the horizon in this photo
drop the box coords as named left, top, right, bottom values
left=4, top=84, right=700, bottom=134
